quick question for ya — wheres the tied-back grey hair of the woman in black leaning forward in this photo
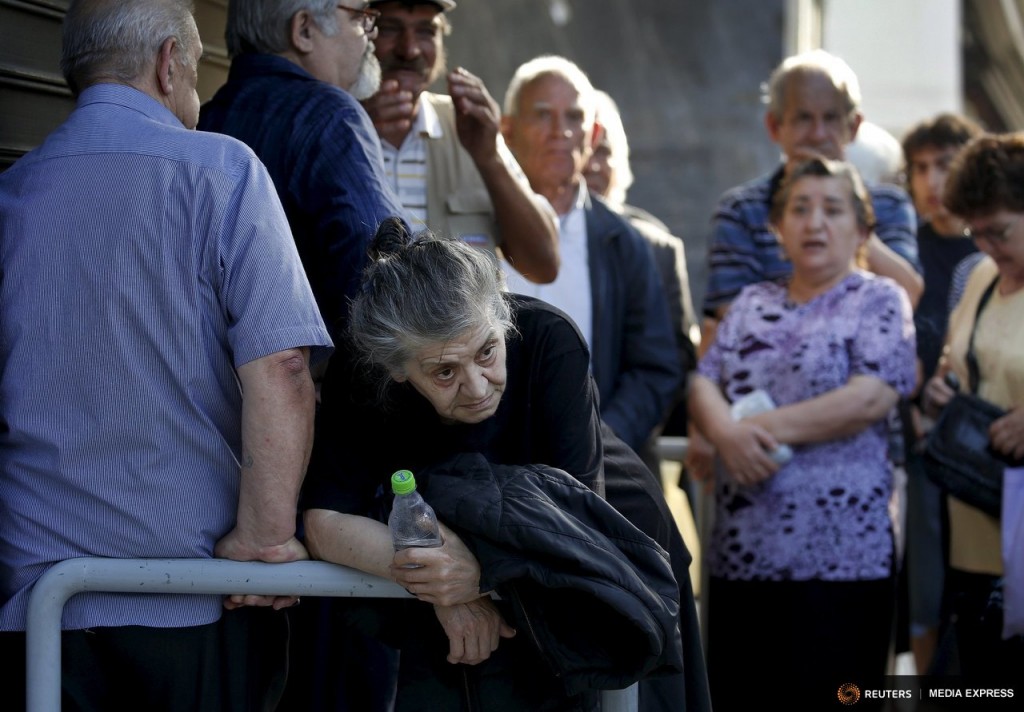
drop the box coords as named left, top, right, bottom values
left=349, top=217, right=514, bottom=393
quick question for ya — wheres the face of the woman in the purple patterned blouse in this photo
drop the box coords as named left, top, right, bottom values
left=776, top=175, right=867, bottom=282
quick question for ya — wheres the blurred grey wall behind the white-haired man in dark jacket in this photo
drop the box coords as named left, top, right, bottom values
left=447, top=0, right=783, bottom=308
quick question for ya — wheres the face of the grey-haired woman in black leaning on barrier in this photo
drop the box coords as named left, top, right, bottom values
left=392, top=324, right=506, bottom=423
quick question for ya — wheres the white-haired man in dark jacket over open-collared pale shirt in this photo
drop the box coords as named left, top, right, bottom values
left=502, top=56, right=683, bottom=451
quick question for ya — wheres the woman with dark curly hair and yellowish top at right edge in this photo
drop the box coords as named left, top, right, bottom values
left=925, top=133, right=1024, bottom=683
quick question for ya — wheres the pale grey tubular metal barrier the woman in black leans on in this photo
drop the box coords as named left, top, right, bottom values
left=26, top=557, right=638, bottom=712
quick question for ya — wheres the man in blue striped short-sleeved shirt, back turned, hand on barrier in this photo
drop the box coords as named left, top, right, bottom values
left=0, top=0, right=332, bottom=710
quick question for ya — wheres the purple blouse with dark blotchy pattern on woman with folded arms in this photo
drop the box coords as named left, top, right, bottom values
left=698, top=271, right=915, bottom=581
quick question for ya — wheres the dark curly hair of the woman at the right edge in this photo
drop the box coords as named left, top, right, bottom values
left=942, top=132, right=1024, bottom=219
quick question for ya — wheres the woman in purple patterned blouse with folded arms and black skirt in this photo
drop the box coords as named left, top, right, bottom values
left=689, top=159, right=915, bottom=710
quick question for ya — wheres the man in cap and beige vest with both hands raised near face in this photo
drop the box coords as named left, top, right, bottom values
left=364, top=0, right=559, bottom=283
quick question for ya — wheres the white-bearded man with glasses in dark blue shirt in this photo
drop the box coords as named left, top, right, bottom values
left=199, top=0, right=404, bottom=346
